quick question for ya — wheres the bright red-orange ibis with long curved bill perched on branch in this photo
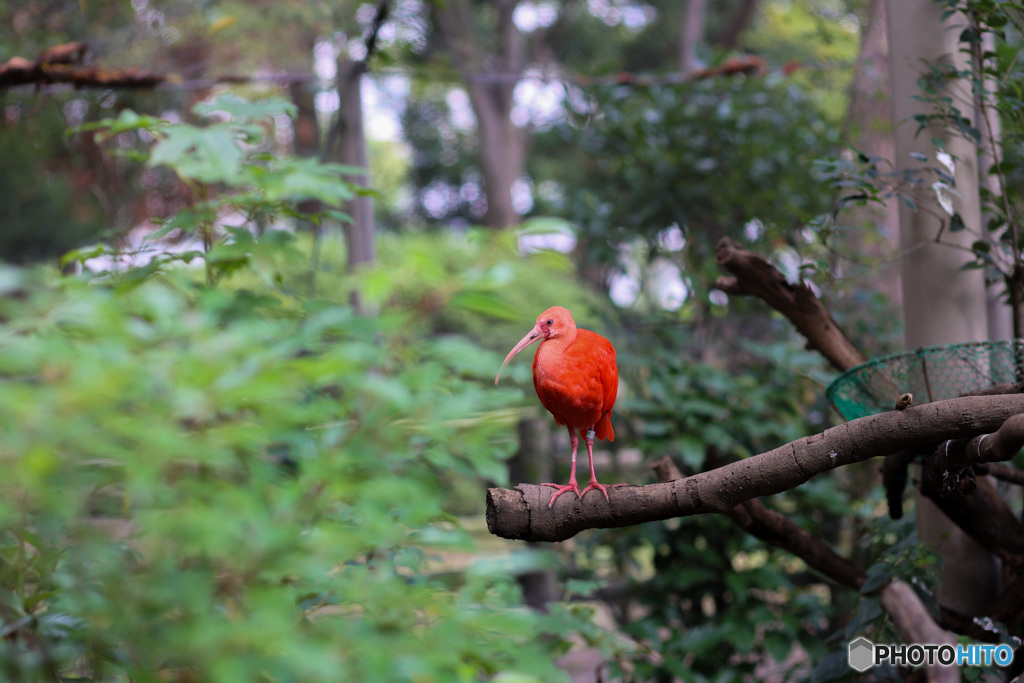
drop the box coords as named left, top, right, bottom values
left=495, top=306, right=626, bottom=508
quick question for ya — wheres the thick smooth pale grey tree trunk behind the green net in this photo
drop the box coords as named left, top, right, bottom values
left=887, top=0, right=999, bottom=614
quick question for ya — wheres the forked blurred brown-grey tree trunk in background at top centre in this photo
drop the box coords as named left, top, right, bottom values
left=433, top=0, right=526, bottom=228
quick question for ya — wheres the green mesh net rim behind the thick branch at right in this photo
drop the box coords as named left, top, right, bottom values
left=825, top=339, right=1024, bottom=420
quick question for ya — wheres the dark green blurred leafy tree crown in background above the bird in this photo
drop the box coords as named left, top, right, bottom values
left=535, top=78, right=837, bottom=301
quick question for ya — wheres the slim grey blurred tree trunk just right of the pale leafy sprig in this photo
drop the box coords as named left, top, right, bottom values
left=337, top=58, right=377, bottom=308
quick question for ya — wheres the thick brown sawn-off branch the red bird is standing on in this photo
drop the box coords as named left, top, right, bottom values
left=486, top=394, right=1024, bottom=542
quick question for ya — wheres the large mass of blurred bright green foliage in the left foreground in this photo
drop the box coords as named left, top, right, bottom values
left=0, top=100, right=629, bottom=681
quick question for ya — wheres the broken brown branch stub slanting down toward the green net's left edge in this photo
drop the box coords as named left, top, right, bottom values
left=715, top=238, right=868, bottom=370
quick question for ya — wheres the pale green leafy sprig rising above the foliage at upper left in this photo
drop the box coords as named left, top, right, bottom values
left=63, top=93, right=364, bottom=284
